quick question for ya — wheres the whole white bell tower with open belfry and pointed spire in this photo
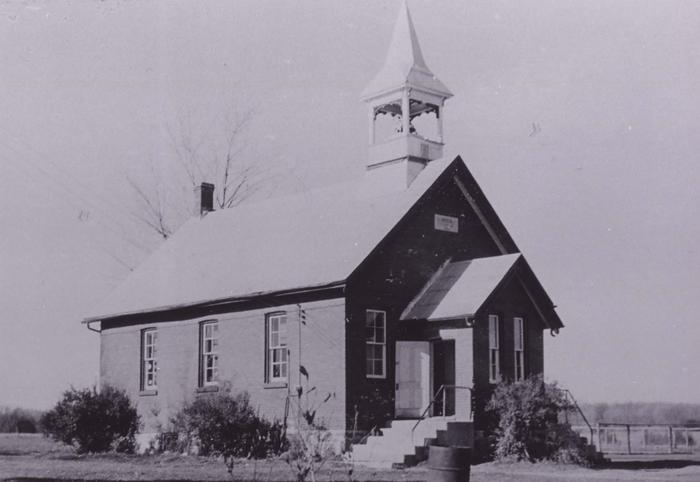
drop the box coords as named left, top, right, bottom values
left=362, top=2, right=452, bottom=189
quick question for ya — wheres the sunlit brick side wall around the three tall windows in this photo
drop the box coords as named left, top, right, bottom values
left=100, top=299, right=345, bottom=433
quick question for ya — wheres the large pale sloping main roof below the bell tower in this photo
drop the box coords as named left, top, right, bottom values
left=86, top=158, right=466, bottom=321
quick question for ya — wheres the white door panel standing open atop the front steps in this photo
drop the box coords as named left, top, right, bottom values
left=395, top=341, right=432, bottom=418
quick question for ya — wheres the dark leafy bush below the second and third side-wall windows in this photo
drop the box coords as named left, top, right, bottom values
left=172, top=392, right=287, bottom=459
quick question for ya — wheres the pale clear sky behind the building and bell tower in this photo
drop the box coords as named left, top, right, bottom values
left=0, top=0, right=700, bottom=408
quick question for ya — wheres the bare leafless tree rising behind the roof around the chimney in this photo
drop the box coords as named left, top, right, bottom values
left=127, top=109, right=270, bottom=239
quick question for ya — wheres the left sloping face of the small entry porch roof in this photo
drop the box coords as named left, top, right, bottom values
left=401, top=253, right=521, bottom=321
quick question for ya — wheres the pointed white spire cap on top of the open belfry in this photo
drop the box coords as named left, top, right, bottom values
left=362, top=0, right=452, bottom=99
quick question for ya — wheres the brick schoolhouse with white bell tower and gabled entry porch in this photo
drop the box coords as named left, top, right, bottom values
left=84, top=1, right=563, bottom=461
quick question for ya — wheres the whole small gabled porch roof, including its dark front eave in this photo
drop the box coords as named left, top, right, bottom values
left=401, top=253, right=563, bottom=330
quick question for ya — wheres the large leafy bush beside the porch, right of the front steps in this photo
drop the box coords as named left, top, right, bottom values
left=487, top=376, right=586, bottom=464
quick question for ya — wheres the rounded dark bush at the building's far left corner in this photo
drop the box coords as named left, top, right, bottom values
left=40, top=386, right=139, bottom=453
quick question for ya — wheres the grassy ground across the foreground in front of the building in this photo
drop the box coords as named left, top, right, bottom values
left=0, top=434, right=700, bottom=482
